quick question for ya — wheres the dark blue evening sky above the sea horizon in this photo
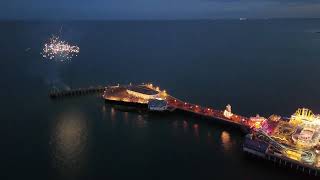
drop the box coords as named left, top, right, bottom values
left=0, top=0, right=320, bottom=19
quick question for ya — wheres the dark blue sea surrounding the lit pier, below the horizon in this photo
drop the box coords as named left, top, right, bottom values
left=0, top=20, right=320, bottom=180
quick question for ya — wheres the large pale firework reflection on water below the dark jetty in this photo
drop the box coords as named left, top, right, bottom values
left=51, top=112, right=88, bottom=170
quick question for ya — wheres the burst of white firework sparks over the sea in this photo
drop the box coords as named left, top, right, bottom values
left=41, top=36, right=80, bottom=61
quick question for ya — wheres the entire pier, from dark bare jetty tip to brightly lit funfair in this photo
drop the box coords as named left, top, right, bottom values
left=49, top=84, right=320, bottom=176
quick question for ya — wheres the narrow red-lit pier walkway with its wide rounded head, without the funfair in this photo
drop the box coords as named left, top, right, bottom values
left=103, top=84, right=261, bottom=129
